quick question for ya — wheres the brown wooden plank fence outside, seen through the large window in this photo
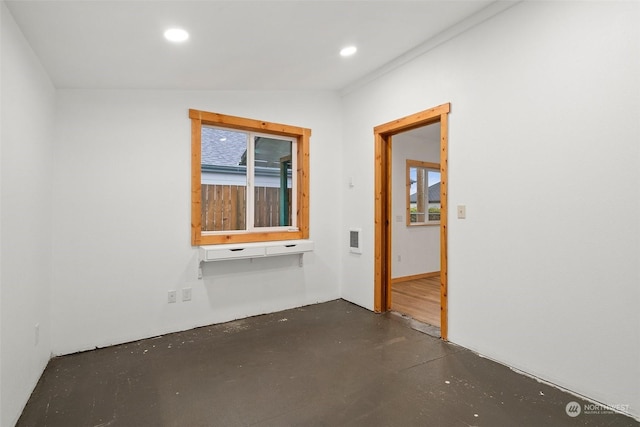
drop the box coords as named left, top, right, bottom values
left=202, top=184, right=291, bottom=231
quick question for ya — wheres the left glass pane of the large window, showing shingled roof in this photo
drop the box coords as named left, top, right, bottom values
left=201, top=126, right=248, bottom=231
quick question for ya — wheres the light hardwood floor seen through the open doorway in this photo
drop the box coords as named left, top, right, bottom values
left=391, top=276, right=440, bottom=328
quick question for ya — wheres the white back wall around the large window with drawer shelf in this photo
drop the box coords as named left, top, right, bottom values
left=52, top=90, right=341, bottom=354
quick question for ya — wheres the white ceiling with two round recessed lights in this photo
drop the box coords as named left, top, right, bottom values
left=5, top=0, right=493, bottom=91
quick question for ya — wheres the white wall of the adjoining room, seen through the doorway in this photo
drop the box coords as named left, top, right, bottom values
left=391, top=123, right=440, bottom=278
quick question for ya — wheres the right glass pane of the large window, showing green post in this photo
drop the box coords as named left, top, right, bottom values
left=254, top=136, right=293, bottom=227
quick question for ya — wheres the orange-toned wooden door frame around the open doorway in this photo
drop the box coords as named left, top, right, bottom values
left=374, top=103, right=450, bottom=340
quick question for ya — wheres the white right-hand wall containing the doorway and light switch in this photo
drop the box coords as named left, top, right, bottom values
left=342, top=2, right=640, bottom=416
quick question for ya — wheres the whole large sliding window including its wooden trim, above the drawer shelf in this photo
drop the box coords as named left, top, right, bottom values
left=189, top=110, right=311, bottom=246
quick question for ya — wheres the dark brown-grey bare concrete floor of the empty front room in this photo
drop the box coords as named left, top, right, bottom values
left=17, top=300, right=639, bottom=427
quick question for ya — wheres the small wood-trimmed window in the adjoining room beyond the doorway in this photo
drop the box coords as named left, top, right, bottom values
left=406, top=160, right=440, bottom=226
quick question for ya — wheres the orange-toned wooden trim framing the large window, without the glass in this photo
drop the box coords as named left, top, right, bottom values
left=189, top=109, right=311, bottom=246
